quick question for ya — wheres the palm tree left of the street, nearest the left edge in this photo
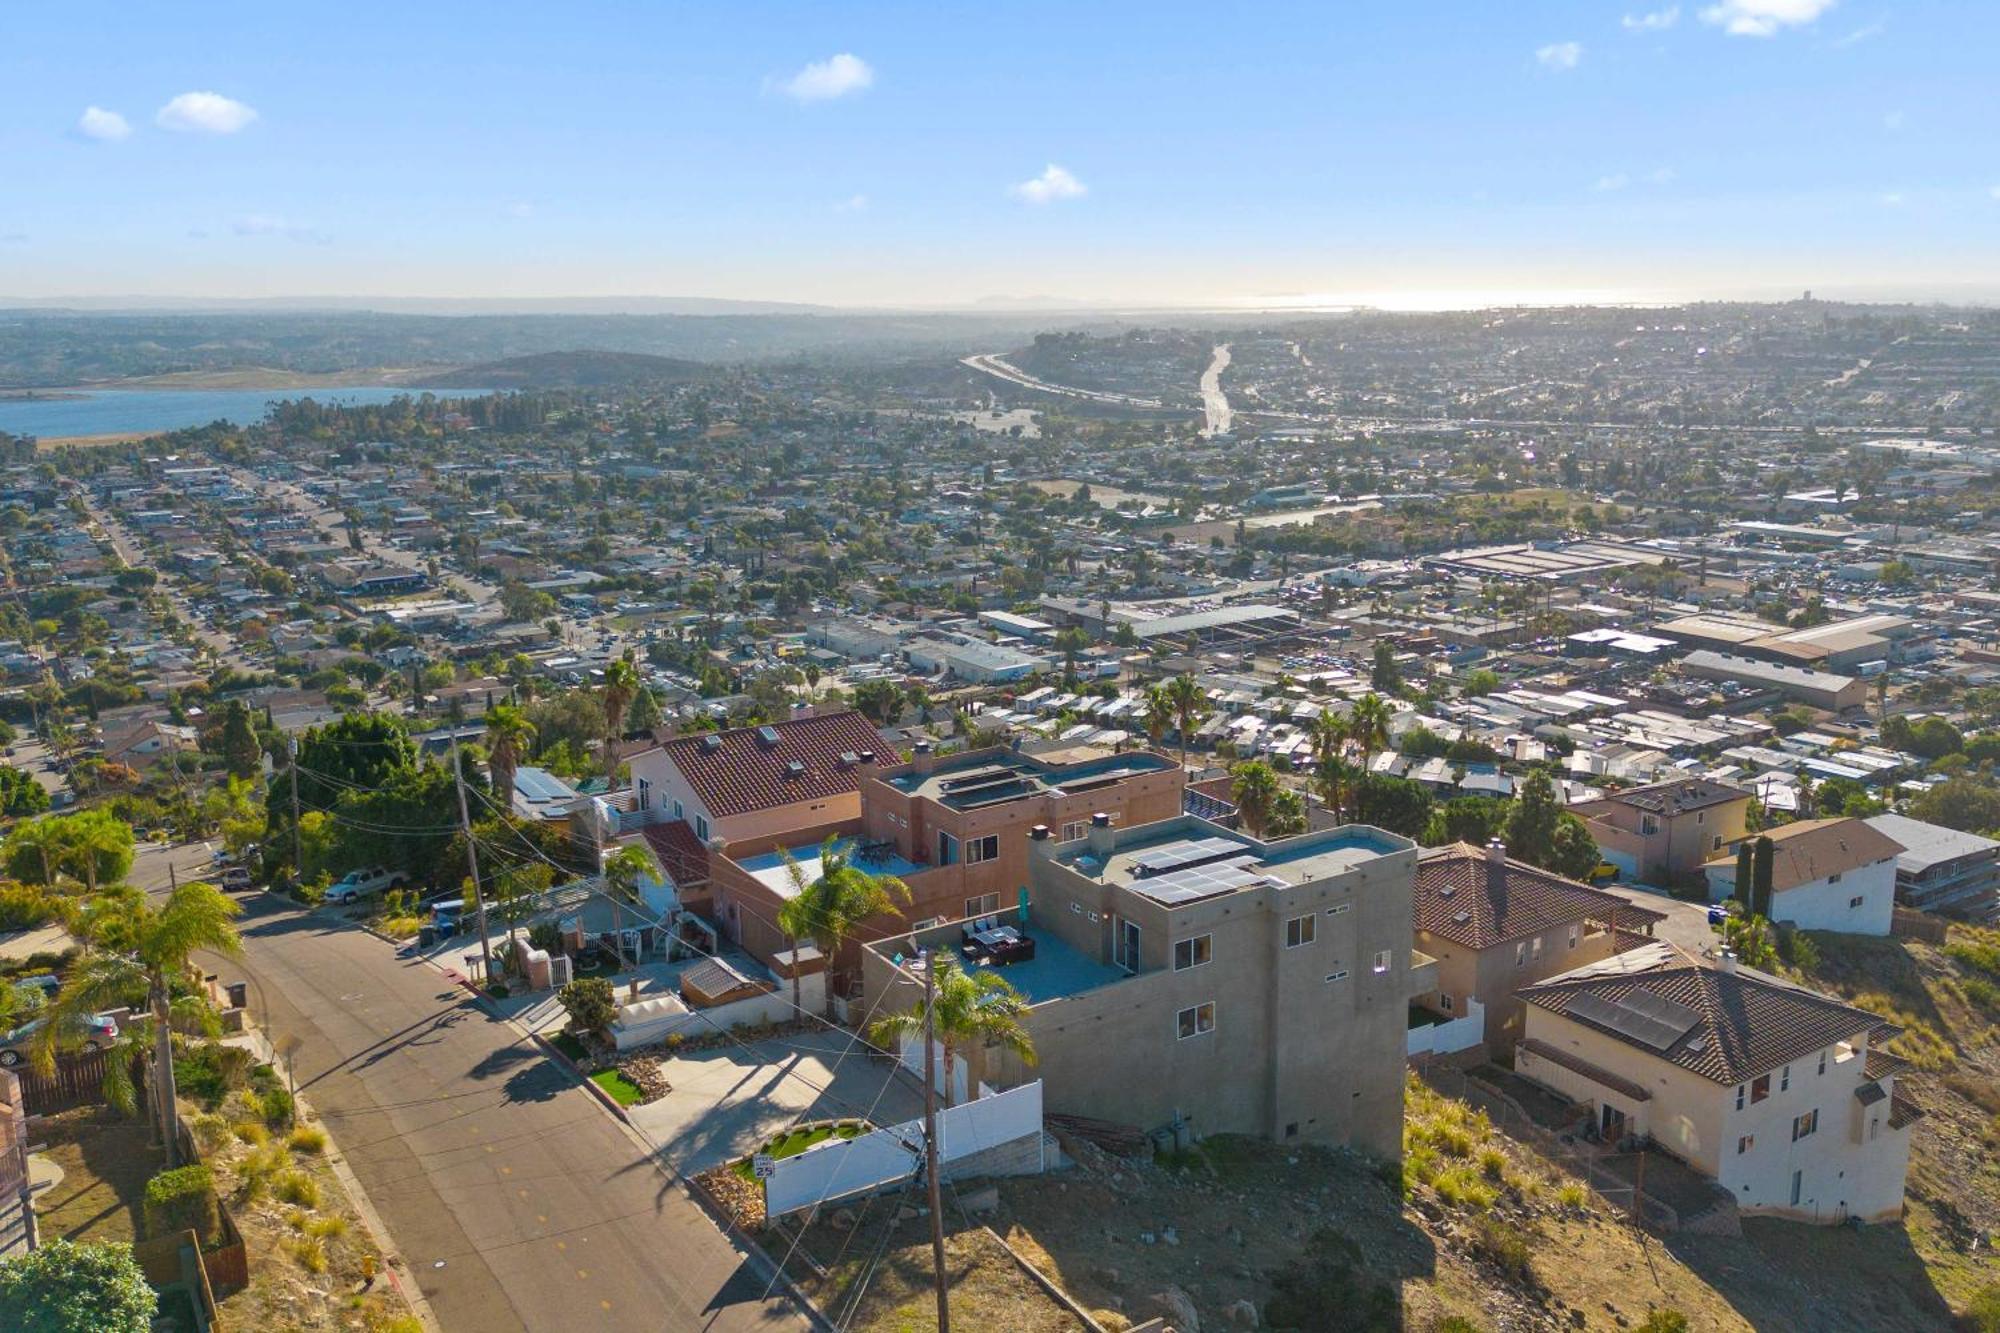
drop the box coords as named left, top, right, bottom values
left=34, top=883, right=242, bottom=1167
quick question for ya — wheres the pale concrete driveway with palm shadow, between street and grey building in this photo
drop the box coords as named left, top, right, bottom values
left=630, top=1029, right=924, bottom=1175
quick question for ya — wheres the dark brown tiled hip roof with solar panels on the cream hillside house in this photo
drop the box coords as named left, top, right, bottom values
left=1518, top=957, right=1882, bottom=1085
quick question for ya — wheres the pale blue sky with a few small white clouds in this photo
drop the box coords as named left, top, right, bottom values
left=0, top=0, right=2000, bottom=308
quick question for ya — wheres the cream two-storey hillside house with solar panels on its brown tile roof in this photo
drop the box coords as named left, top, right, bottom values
left=1514, top=945, right=1922, bottom=1223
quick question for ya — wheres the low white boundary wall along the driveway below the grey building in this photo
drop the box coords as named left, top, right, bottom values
left=764, top=1081, right=1042, bottom=1217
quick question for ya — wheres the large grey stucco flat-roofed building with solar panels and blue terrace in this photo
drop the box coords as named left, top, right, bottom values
left=862, top=815, right=1436, bottom=1157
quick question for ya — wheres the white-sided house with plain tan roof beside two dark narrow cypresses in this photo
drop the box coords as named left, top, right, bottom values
left=1704, top=819, right=1904, bottom=935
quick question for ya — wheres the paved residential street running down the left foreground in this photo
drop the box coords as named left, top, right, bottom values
left=206, top=895, right=812, bottom=1333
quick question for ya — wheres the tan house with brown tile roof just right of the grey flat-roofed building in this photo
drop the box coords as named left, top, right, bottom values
left=1412, top=843, right=1666, bottom=1051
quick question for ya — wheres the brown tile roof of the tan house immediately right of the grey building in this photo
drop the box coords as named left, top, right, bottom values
left=1414, top=843, right=1666, bottom=949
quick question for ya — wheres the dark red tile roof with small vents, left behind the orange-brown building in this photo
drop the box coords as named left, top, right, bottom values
left=660, top=709, right=896, bottom=819
